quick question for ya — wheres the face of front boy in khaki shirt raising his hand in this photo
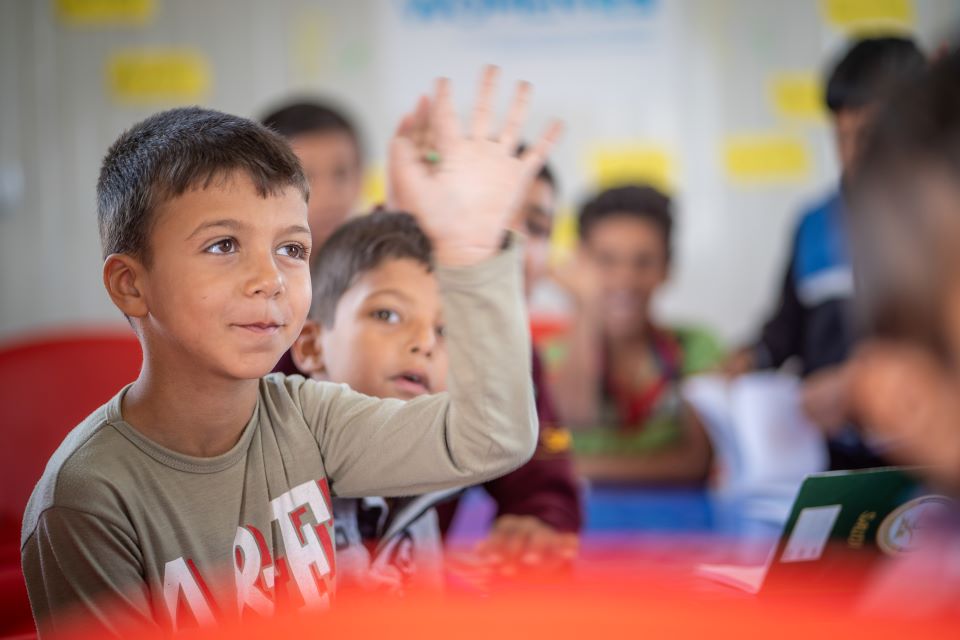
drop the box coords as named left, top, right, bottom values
left=138, top=172, right=310, bottom=379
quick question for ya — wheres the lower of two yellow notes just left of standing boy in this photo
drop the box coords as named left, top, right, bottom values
left=723, top=132, right=813, bottom=183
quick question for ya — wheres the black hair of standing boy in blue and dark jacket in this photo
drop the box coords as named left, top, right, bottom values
left=826, top=36, right=926, bottom=113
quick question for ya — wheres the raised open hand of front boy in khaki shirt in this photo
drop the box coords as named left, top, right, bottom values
left=388, top=67, right=562, bottom=266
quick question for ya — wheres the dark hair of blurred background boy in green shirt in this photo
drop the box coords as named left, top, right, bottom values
left=579, top=185, right=673, bottom=261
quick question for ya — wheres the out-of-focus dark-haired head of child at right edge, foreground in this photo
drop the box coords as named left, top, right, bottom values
left=851, top=45, right=960, bottom=353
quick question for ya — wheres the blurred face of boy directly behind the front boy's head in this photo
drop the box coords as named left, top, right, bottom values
left=290, top=131, right=362, bottom=247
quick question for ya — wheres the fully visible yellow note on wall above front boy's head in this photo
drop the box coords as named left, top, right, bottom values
left=107, top=49, right=211, bottom=105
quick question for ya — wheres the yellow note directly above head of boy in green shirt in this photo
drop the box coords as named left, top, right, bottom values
left=587, top=142, right=674, bottom=191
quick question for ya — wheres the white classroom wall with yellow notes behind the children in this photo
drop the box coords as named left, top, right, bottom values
left=0, top=0, right=960, bottom=340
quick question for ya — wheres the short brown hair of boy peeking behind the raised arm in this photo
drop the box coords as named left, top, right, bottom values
left=310, top=211, right=433, bottom=327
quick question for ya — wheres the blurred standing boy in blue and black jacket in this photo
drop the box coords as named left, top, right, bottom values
left=725, top=37, right=926, bottom=469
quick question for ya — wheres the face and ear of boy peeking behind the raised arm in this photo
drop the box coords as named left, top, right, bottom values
left=294, top=258, right=447, bottom=400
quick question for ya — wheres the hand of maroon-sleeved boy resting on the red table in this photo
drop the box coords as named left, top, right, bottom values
left=477, top=514, right=579, bottom=577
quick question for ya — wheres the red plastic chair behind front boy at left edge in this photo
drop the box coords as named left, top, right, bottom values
left=0, top=327, right=142, bottom=636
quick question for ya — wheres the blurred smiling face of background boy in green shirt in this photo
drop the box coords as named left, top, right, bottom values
left=583, top=214, right=667, bottom=338
